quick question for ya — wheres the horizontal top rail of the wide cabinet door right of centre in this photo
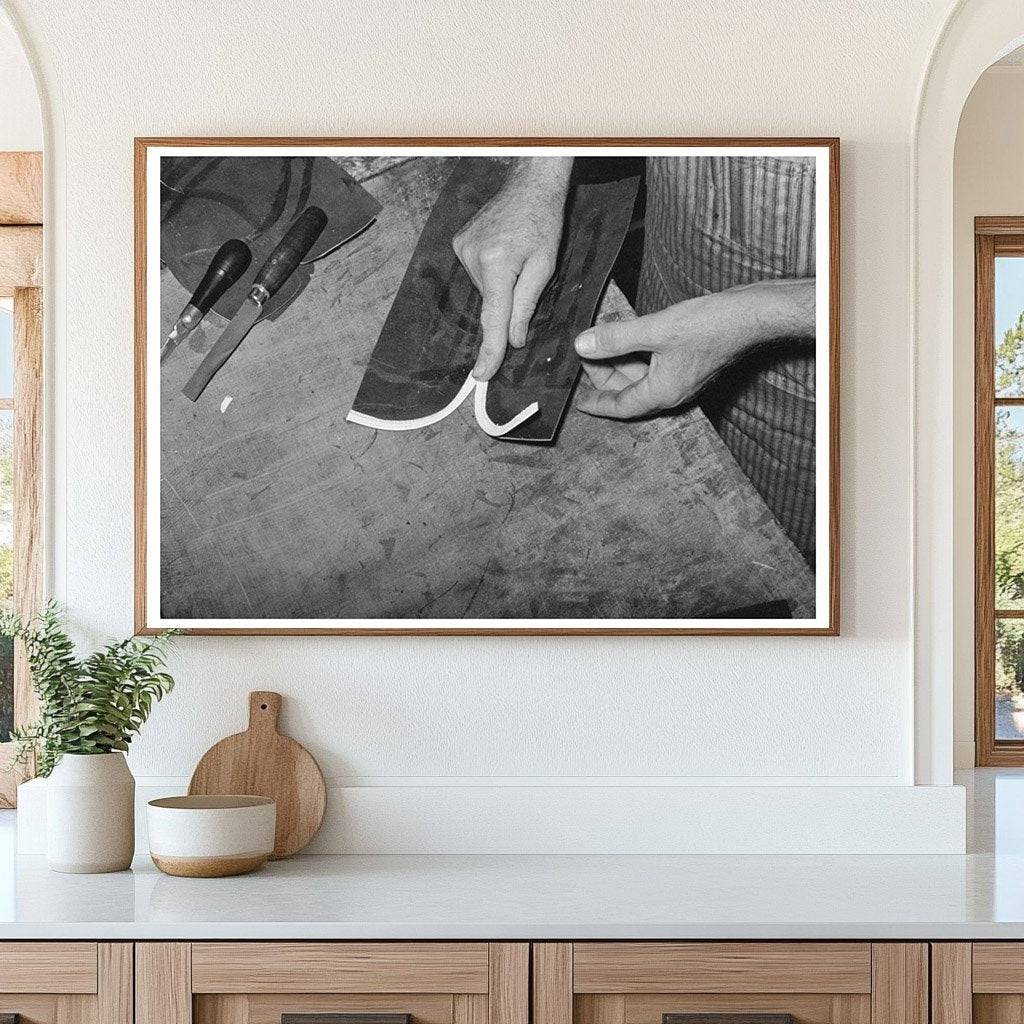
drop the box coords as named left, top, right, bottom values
left=572, top=942, right=871, bottom=993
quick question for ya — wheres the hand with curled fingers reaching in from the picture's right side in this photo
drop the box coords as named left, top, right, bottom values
left=575, top=278, right=814, bottom=420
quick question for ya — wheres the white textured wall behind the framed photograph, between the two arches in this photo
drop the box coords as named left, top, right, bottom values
left=4, top=0, right=974, bottom=847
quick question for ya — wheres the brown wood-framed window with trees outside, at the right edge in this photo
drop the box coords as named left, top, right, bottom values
left=975, top=217, right=1024, bottom=765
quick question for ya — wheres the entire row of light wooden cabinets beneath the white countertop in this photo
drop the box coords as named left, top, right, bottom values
left=0, top=942, right=942, bottom=1024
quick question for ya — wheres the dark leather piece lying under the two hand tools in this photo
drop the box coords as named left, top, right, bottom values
left=160, top=157, right=381, bottom=319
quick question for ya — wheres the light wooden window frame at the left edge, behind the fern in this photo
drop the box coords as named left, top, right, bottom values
left=0, top=153, right=43, bottom=807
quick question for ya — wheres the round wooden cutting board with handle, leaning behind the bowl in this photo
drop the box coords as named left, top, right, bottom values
left=188, top=690, right=327, bottom=860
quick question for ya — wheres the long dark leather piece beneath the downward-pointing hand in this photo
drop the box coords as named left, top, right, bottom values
left=352, top=157, right=638, bottom=442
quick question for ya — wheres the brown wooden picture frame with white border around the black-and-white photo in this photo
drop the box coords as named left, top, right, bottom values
left=134, top=137, right=840, bottom=636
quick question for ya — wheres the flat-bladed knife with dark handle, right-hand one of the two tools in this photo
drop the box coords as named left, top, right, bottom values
left=181, top=206, right=327, bottom=401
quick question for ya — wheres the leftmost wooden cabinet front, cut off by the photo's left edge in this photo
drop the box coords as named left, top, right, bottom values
left=0, top=942, right=132, bottom=1024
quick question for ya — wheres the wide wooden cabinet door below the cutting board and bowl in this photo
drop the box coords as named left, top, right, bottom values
left=135, top=942, right=529, bottom=1024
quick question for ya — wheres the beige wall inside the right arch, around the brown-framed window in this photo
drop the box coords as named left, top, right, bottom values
left=953, top=63, right=1024, bottom=768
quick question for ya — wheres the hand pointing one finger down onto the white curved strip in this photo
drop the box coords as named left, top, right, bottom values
left=452, top=157, right=572, bottom=381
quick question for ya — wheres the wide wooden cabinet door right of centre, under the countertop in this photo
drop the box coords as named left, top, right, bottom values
left=534, top=942, right=928, bottom=1024
